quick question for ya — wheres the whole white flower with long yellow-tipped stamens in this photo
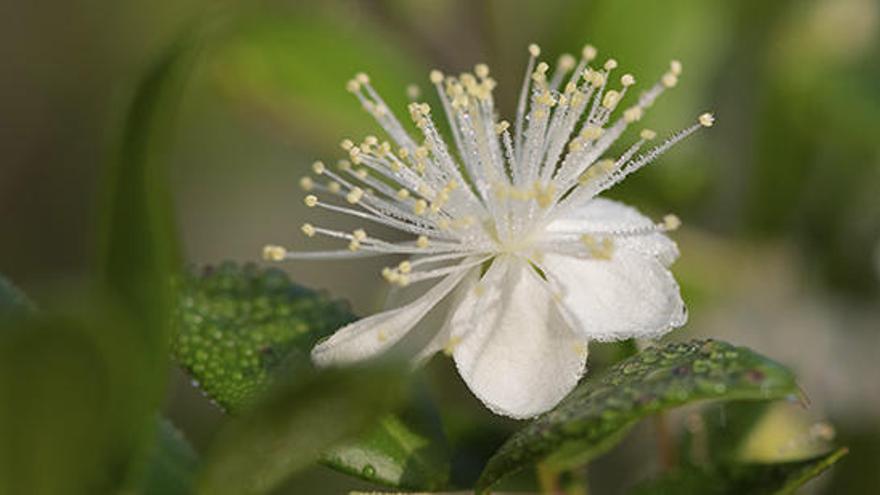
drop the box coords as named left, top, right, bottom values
left=264, top=45, right=713, bottom=418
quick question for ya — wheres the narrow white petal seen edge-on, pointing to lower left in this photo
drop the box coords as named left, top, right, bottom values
left=312, top=270, right=468, bottom=366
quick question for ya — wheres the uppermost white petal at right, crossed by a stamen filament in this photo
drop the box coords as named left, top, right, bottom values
left=547, top=198, right=678, bottom=266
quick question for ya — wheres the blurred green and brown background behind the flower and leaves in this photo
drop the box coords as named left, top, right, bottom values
left=0, top=0, right=880, bottom=493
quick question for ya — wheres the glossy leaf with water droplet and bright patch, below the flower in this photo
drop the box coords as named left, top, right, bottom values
left=322, top=397, right=450, bottom=491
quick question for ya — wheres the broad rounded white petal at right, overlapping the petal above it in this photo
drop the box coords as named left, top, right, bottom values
left=541, top=248, right=687, bottom=341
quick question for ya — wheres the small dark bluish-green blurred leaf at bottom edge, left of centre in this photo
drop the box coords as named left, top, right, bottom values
left=138, top=418, right=199, bottom=495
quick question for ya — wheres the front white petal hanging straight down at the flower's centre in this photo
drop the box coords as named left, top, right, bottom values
left=450, top=258, right=587, bottom=418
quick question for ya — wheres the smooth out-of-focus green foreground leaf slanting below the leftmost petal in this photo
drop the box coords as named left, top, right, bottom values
left=199, top=365, right=406, bottom=495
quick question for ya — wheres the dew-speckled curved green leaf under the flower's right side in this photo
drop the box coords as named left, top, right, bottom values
left=477, top=340, right=797, bottom=493
